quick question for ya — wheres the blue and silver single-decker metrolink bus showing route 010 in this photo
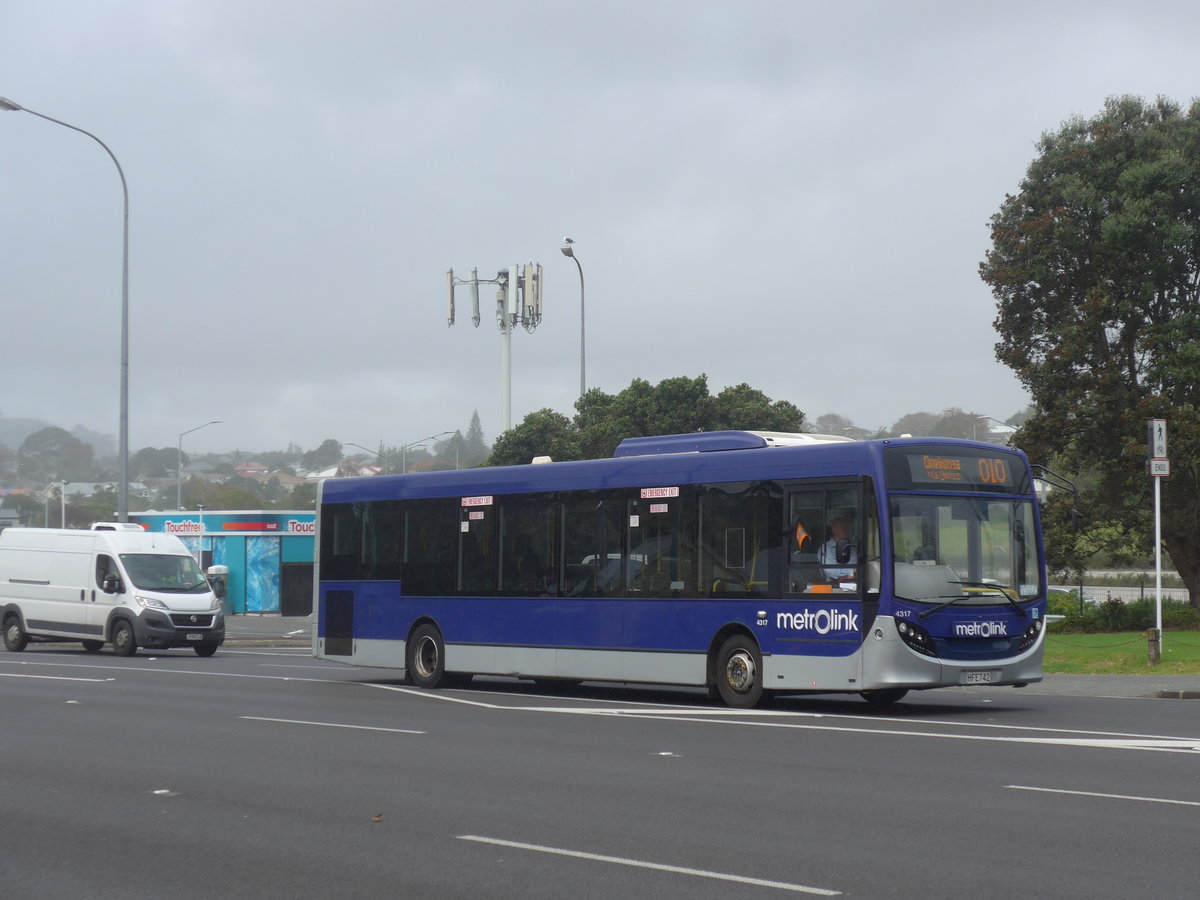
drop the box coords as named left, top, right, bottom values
left=313, top=431, right=1046, bottom=707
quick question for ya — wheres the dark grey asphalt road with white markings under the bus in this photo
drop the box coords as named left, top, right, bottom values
left=0, top=643, right=1200, bottom=900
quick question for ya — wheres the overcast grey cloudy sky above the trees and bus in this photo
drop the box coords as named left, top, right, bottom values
left=0, top=0, right=1200, bottom=452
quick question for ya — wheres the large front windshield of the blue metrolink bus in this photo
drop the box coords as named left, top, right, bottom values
left=890, top=494, right=1040, bottom=604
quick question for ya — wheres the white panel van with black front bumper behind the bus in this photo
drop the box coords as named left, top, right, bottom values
left=0, top=526, right=224, bottom=656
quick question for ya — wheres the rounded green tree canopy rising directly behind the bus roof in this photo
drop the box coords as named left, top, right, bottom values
left=490, top=374, right=804, bottom=466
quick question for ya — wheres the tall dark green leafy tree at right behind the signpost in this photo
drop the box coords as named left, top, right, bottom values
left=980, top=97, right=1200, bottom=608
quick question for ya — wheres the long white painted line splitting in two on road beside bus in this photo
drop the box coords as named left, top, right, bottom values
left=368, top=684, right=1200, bottom=754
